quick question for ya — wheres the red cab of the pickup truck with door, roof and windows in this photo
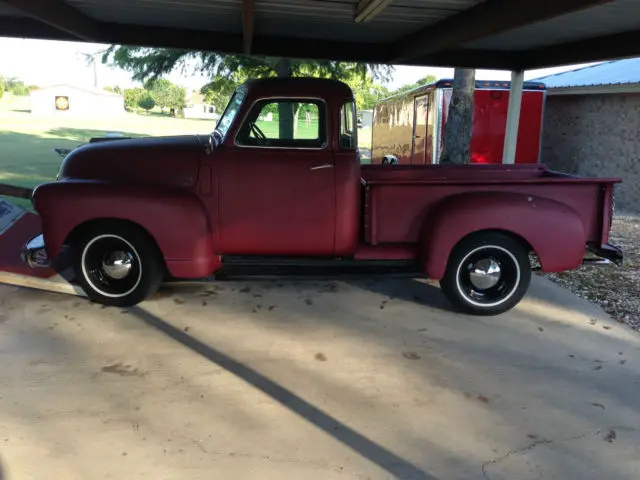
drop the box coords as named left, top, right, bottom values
left=204, top=79, right=360, bottom=256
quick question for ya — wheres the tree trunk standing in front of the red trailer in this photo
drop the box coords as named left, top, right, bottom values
left=440, top=68, right=476, bottom=165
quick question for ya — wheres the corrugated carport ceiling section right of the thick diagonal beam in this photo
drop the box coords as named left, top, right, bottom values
left=465, top=0, right=640, bottom=50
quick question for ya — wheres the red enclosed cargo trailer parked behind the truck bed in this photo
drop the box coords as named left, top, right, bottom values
left=371, top=80, right=546, bottom=165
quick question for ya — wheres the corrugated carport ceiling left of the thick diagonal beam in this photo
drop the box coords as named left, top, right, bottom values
left=67, top=0, right=481, bottom=42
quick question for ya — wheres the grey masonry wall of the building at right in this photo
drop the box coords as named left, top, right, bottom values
left=542, top=94, right=640, bottom=213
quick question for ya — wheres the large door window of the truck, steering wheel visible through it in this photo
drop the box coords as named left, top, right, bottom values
left=236, top=99, right=327, bottom=148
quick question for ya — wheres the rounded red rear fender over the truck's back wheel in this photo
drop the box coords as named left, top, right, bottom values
left=421, top=192, right=587, bottom=280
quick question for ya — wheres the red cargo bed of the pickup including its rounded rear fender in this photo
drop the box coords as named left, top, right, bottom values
left=362, top=166, right=617, bottom=279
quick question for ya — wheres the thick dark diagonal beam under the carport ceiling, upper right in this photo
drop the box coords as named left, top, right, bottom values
left=393, top=0, right=612, bottom=63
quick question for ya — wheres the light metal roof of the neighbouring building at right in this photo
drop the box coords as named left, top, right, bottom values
left=535, top=58, right=640, bottom=88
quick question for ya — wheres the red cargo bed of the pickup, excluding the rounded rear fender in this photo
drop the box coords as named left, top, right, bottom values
left=362, top=165, right=620, bottom=245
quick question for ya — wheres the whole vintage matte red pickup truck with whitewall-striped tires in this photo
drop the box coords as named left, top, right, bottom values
left=23, top=78, right=622, bottom=315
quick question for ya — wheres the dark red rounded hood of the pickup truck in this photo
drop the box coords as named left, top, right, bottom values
left=58, top=135, right=210, bottom=188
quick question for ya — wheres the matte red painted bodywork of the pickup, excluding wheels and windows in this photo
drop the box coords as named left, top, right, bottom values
left=34, top=79, right=618, bottom=302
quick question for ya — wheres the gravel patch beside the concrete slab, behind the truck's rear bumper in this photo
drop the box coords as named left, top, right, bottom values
left=545, top=215, right=640, bottom=331
